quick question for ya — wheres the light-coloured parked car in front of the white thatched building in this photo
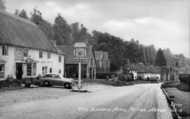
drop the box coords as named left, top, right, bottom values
left=39, top=74, right=74, bottom=89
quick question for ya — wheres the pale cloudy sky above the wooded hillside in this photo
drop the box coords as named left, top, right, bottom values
left=4, top=0, right=190, bottom=57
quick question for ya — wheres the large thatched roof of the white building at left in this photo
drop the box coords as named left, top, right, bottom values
left=0, top=11, right=56, bottom=52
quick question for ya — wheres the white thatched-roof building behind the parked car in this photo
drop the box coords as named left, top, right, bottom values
left=0, top=11, right=64, bottom=80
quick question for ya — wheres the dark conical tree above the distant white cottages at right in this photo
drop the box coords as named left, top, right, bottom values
left=155, top=49, right=167, bottom=67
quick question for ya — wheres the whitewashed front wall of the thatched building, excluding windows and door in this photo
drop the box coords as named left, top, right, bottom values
left=0, top=45, right=64, bottom=80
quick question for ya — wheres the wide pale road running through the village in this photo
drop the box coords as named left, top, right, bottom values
left=0, top=84, right=172, bottom=119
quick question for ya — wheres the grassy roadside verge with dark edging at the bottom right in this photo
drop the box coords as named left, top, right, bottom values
left=162, top=81, right=190, bottom=119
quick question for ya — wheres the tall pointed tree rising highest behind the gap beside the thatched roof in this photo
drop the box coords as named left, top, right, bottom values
left=53, top=14, right=73, bottom=45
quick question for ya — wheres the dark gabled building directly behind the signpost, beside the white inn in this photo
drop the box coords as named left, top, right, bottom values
left=59, top=42, right=96, bottom=79
